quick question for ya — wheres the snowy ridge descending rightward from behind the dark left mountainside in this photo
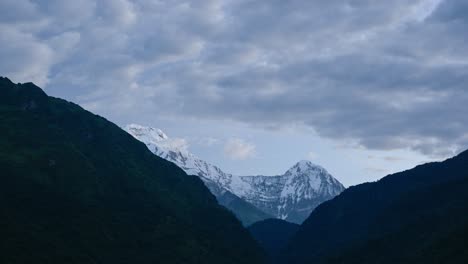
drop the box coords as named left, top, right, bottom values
left=124, top=124, right=272, bottom=226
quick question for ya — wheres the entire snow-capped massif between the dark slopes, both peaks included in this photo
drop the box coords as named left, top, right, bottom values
left=124, top=124, right=344, bottom=223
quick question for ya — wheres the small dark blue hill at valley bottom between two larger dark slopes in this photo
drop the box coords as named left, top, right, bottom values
left=248, top=219, right=299, bottom=263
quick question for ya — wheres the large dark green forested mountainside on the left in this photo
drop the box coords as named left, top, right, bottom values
left=0, top=78, right=262, bottom=264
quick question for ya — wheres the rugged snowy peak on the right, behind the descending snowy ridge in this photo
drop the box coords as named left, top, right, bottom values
left=241, top=161, right=345, bottom=224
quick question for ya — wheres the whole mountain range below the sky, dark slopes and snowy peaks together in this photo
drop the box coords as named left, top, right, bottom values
left=0, top=77, right=468, bottom=264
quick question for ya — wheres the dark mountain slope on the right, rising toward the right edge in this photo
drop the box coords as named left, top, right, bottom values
left=284, top=152, right=468, bottom=263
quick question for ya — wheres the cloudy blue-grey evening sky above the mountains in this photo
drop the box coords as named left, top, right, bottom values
left=0, top=0, right=468, bottom=186
